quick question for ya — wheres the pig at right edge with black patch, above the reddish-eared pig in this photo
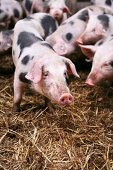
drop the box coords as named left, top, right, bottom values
left=77, top=11, right=113, bottom=45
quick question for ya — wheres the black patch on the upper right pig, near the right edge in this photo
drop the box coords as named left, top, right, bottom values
left=98, top=15, right=109, bottom=29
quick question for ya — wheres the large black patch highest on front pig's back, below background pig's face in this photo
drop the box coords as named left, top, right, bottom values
left=41, top=15, right=57, bottom=39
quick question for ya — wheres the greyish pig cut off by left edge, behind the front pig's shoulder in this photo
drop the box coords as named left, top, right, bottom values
left=0, top=29, right=14, bottom=54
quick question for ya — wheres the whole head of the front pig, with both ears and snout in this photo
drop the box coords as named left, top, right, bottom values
left=25, top=56, right=79, bottom=105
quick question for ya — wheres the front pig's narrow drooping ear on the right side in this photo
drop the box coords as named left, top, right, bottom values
left=63, top=57, right=80, bottom=78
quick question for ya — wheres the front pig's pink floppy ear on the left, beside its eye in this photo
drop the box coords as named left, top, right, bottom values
left=25, top=63, right=42, bottom=83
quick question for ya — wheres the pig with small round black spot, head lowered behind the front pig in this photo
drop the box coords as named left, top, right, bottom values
left=46, top=6, right=113, bottom=56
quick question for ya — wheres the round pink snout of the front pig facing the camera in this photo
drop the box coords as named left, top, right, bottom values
left=59, top=93, right=74, bottom=105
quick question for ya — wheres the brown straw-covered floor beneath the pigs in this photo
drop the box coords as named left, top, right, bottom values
left=0, top=53, right=113, bottom=170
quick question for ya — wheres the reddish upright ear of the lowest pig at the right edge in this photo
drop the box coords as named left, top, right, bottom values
left=79, top=44, right=96, bottom=60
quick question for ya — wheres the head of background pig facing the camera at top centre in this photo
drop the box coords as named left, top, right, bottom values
left=45, top=0, right=71, bottom=25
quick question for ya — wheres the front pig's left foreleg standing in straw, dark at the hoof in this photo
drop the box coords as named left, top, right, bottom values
left=13, top=75, right=24, bottom=112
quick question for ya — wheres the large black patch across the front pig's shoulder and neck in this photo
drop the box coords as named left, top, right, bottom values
left=17, top=31, right=43, bottom=50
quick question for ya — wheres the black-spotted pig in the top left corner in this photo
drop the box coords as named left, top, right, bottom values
left=0, top=0, right=23, bottom=30
